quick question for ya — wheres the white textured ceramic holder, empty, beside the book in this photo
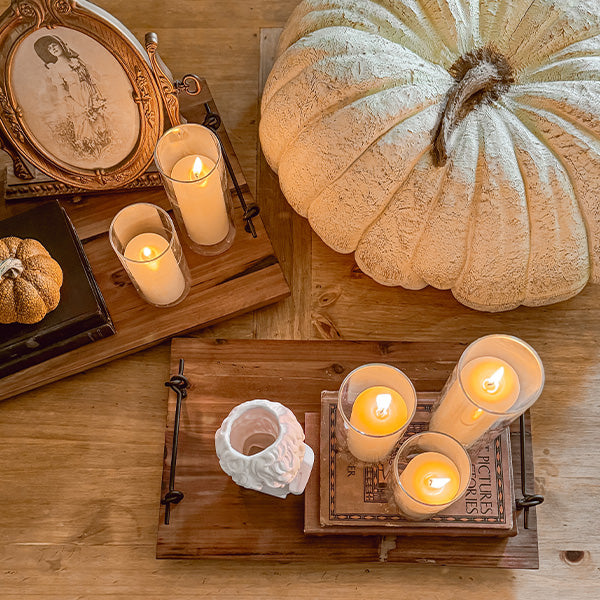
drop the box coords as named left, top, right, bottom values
left=215, top=400, right=315, bottom=498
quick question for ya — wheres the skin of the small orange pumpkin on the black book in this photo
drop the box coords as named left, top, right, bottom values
left=0, top=237, right=63, bottom=324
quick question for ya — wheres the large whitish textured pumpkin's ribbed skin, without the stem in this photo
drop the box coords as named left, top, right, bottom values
left=260, top=0, right=600, bottom=311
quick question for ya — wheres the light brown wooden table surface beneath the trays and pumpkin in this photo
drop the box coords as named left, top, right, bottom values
left=0, top=0, right=600, bottom=600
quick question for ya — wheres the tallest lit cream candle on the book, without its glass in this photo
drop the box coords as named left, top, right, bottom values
left=429, top=356, right=520, bottom=447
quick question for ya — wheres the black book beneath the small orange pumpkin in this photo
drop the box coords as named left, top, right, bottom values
left=0, top=202, right=115, bottom=377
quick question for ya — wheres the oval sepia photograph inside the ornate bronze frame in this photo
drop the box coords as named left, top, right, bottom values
left=10, top=26, right=140, bottom=172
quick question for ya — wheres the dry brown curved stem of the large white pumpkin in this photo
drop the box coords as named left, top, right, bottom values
left=433, top=47, right=514, bottom=166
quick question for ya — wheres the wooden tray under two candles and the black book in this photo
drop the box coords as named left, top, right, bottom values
left=0, top=83, right=289, bottom=400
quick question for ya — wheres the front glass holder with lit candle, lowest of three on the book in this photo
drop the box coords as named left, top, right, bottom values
left=391, top=431, right=471, bottom=521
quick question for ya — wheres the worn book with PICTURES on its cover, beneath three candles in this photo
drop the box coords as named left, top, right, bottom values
left=305, top=392, right=517, bottom=536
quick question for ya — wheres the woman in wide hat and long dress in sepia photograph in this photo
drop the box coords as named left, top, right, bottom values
left=34, top=35, right=111, bottom=158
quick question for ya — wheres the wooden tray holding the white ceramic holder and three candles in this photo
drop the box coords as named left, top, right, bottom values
left=156, top=338, right=538, bottom=569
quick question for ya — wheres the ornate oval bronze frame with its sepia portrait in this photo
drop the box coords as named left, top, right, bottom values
left=0, top=0, right=165, bottom=190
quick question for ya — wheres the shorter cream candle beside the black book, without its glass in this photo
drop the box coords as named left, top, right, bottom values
left=124, top=233, right=185, bottom=306
